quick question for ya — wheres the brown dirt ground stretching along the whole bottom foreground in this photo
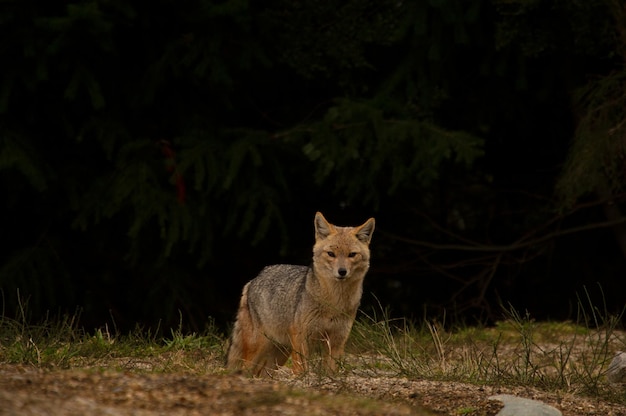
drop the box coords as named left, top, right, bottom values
left=0, top=364, right=626, bottom=416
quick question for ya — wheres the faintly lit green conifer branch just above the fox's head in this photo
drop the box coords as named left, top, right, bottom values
left=286, top=100, right=483, bottom=205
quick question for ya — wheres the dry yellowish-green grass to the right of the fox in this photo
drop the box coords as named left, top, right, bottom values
left=345, top=292, right=626, bottom=403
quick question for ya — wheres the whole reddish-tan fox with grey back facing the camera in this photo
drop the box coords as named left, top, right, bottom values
left=226, top=212, right=375, bottom=377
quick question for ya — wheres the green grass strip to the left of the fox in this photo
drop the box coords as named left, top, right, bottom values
left=0, top=298, right=224, bottom=372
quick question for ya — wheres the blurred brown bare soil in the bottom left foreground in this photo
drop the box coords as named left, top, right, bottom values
left=0, top=365, right=422, bottom=416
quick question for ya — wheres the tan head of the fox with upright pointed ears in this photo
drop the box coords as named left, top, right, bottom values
left=313, top=212, right=374, bottom=280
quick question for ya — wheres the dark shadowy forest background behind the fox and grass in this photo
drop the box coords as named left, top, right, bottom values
left=0, top=0, right=626, bottom=330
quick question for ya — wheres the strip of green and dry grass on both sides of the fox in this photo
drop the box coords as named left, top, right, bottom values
left=0, top=290, right=626, bottom=404
